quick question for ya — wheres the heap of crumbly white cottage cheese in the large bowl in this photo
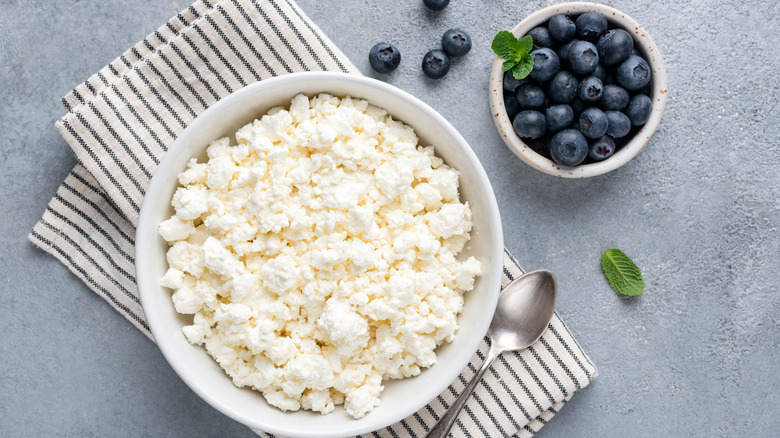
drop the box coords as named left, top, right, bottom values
left=159, top=94, right=480, bottom=418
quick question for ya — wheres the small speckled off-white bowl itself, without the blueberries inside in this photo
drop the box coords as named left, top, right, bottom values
left=489, top=2, right=667, bottom=178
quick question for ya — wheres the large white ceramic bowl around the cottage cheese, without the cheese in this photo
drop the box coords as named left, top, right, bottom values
left=135, top=73, right=503, bottom=437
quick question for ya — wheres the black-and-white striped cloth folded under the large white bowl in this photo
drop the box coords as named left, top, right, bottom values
left=29, top=0, right=596, bottom=437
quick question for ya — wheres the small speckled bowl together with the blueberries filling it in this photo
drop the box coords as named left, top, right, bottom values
left=490, top=2, right=667, bottom=178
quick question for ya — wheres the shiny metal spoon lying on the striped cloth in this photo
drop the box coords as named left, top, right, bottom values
left=427, top=269, right=558, bottom=438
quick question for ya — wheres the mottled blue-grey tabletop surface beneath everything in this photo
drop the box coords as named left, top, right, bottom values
left=0, top=0, right=780, bottom=437
